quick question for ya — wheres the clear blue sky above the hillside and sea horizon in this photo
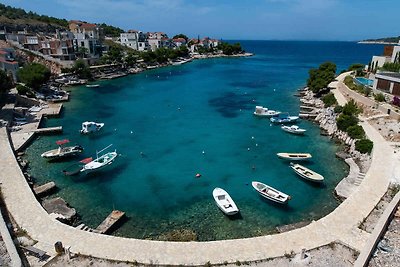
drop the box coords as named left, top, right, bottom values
left=0, top=0, right=400, bottom=41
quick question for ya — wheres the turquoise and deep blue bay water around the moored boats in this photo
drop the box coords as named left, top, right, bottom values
left=26, top=41, right=381, bottom=240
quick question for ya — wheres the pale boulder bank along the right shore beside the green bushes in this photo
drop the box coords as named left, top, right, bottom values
left=300, top=90, right=371, bottom=172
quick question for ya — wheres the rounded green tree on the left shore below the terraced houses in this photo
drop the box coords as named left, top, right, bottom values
left=17, top=63, right=51, bottom=90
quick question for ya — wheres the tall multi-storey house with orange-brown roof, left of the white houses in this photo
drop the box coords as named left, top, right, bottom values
left=69, top=20, right=104, bottom=58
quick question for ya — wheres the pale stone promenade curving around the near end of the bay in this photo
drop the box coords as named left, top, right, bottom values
left=0, top=98, right=396, bottom=265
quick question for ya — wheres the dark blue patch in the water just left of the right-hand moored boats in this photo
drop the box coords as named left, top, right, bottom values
left=208, top=92, right=254, bottom=118
